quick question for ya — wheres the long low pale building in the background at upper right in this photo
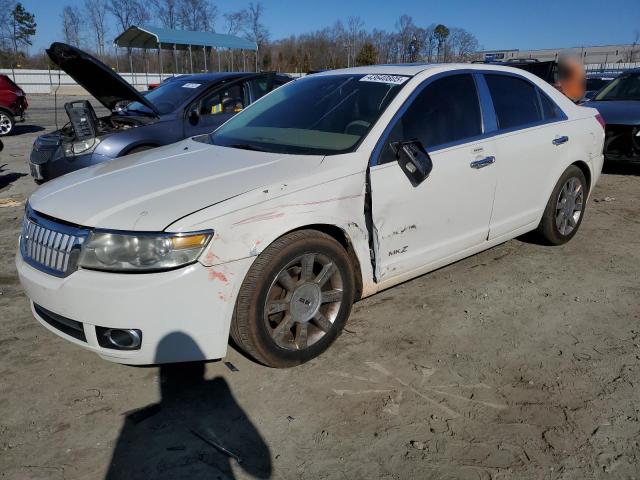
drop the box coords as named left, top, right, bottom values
left=478, top=44, right=640, bottom=64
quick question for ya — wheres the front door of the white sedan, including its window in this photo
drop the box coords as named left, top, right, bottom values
left=370, top=74, right=496, bottom=282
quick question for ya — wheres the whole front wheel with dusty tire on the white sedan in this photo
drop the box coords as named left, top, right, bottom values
left=231, top=230, right=355, bottom=368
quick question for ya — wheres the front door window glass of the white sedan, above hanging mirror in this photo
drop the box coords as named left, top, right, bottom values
left=380, top=74, right=482, bottom=163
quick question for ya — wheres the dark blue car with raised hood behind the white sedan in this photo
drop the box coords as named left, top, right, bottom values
left=29, top=43, right=291, bottom=183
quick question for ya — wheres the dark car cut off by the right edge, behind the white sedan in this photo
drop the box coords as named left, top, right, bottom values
left=585, top=68, right=640, bottom=162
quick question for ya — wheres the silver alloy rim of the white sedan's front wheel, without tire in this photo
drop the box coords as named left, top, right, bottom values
left=264, top=253, right=344, bottom=350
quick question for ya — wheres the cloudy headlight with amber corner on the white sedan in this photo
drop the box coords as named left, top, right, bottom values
left=78, top=230, right=213, bottom=272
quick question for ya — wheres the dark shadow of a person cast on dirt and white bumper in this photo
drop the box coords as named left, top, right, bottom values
left=105, top=332, right=272, bottom=480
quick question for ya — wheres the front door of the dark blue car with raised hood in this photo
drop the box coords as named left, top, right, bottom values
left=184, top=82, right=249, bottom=137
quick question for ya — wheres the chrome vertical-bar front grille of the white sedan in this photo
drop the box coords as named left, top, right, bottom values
left=20, top=209, right=89, bottom=277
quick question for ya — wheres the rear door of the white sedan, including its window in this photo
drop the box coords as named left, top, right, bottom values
left=484, top=72, right=576, bottom=239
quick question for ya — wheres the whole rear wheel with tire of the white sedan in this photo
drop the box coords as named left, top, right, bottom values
left=538, top=165, right=589, bottom=245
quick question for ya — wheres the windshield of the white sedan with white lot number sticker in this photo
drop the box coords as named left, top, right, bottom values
left=211, top=74, right=409, bottom=155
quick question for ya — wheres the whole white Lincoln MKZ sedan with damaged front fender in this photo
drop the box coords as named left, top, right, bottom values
left=16, top=64, right=604, bottom=367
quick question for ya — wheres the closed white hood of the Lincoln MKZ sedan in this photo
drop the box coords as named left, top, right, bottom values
left=29, top=139, right=323, bottom=231
